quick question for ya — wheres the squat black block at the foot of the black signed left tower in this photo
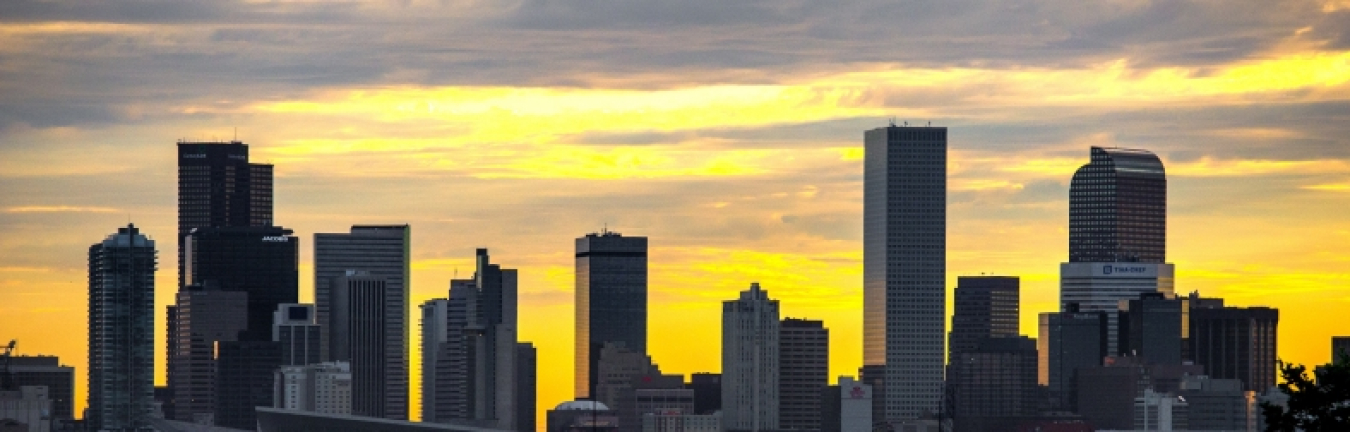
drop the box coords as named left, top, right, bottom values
left=215, top=340, right=282, bottom=429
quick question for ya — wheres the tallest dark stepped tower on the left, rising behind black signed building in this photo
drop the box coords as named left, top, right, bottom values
left=178, top=140, right=273, bottom=288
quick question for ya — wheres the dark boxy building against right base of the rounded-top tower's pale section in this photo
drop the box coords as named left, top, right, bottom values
left=1116, top=293, right=1191, bottom=365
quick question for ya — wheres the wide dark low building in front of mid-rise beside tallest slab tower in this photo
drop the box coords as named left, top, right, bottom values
left=946, top=336, right=1040, bottom=431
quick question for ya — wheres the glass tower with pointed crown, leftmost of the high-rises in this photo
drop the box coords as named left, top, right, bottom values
left=85, top=224, right=157, bottom=429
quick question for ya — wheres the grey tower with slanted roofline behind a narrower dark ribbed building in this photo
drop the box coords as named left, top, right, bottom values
left=315, top=225, right=412, bottom=364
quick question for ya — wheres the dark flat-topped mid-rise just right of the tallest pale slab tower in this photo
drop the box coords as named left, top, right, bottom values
left=949, top=275, right=1021, bottom=356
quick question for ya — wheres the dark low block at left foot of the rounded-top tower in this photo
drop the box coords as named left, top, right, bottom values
left=1037, top=306, right=1107, bottom=410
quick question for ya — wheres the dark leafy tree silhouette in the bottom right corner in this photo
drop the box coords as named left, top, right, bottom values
left=1261, top=354, right=1350, bottom=432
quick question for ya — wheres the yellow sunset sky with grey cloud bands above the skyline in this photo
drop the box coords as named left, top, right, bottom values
left=0, top=0, right=1350, bottom=425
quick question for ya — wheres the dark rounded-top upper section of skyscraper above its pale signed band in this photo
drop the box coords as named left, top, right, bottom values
left=1069, top=147, right=1168, bottom=263
